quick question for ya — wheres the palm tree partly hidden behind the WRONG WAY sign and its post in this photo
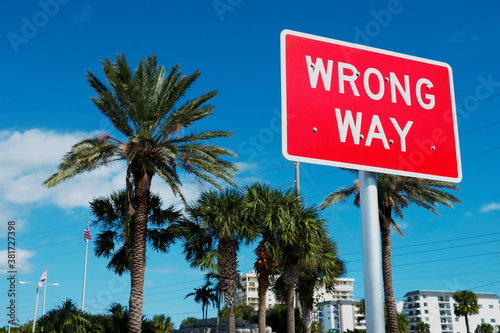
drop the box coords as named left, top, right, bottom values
left=321, top=173, right=460, bottom=333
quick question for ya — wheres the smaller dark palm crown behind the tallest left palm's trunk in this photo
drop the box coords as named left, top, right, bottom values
left=90, top=190, right=182, bottom=275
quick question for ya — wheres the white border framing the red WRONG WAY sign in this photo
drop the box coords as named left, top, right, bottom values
left=280, top=29, right=462, bottom=183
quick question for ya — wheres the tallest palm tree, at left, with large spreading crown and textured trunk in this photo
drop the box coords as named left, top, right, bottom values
left=43, top=54, right=237, bottom=333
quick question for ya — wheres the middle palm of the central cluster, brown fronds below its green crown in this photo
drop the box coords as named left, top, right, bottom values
left=245, top=183, right=300, bottom=332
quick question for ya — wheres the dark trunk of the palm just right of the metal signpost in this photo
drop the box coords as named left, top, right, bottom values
left=380, top=216, right=399, bottom=333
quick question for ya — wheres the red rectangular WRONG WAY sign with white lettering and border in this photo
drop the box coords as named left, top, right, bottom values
left=281, top=30, right=462, bottom=182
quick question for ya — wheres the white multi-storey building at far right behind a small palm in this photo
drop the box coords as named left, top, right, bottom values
left=403, top=290, right=500, bottom=333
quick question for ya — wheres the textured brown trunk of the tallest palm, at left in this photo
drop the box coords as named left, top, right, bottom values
left=128, top=172, right=151, bottom=333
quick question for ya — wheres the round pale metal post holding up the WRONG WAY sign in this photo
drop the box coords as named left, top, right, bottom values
left=359, top=171, right=385, bottom=333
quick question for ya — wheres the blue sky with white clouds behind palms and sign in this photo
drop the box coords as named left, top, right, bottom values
left=0, top=0, right=500, bottom=326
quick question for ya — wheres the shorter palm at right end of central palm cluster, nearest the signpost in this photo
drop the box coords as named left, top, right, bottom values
left=297, top=235, right=345, bottom=333
